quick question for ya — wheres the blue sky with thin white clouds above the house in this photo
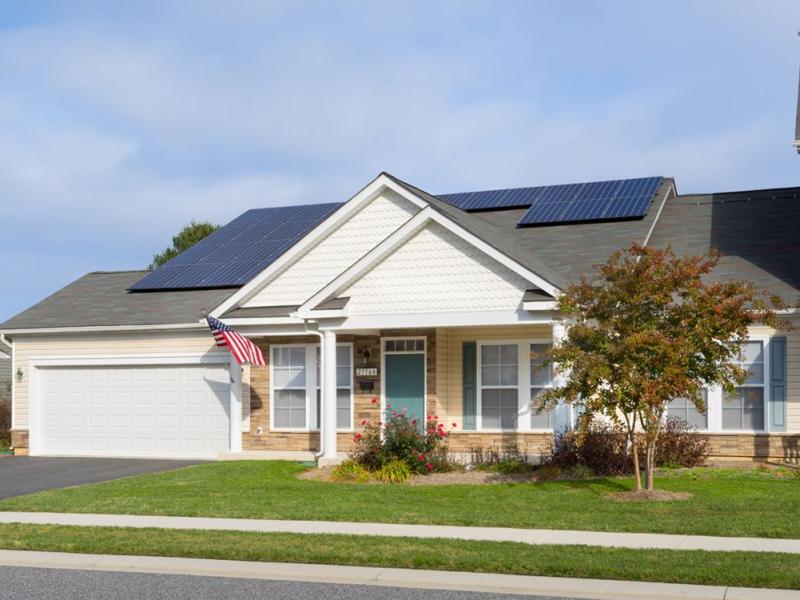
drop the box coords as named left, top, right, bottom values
left=0, top=0, right=800, bottom=321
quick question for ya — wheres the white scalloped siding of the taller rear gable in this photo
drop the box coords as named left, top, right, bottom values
left=243, top=190, right=419, bottom=306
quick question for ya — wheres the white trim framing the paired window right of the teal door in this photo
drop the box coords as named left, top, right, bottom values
left=475, top=338, right=555, bottom=433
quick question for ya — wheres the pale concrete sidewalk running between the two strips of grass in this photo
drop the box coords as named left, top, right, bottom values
left=0, top=512, right=800, bottom=554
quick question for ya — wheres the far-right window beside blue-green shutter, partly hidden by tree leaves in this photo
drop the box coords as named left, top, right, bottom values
left=722, top=342, right=764, bottom=431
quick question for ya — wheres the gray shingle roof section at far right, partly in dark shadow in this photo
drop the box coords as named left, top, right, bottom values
left=650, top=188, right=800, bottom=304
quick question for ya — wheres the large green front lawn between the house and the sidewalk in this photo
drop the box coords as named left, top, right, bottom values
left=0, top=461, right=800, bottom=538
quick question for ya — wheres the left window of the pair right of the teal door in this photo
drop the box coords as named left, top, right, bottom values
left=480, top=344, right=519, bottom=429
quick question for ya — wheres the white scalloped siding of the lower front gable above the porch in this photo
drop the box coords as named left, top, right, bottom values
left=340, top=223, right=531, bottom=315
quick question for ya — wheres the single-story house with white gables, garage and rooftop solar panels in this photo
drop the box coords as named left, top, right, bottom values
left=0, top=173, right=800, bottom=461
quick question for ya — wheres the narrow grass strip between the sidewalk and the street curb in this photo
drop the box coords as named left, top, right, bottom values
left=0, top=525, right=800, bottom=589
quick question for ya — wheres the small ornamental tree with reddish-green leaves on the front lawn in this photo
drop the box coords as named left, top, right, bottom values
left=539, top=244, right=788, bottom=491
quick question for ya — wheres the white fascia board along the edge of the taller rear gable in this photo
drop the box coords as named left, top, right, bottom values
left=209, top=173, right=427, bottom=318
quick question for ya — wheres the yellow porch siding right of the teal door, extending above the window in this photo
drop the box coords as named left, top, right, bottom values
left=436, top=325, right=552, bottom=428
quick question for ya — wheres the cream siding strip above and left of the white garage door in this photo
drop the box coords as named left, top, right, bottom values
left=14, top=330, right=216, bottom=429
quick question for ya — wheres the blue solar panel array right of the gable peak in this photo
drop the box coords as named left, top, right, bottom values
left=439, top=177, right=662, bottom=225
